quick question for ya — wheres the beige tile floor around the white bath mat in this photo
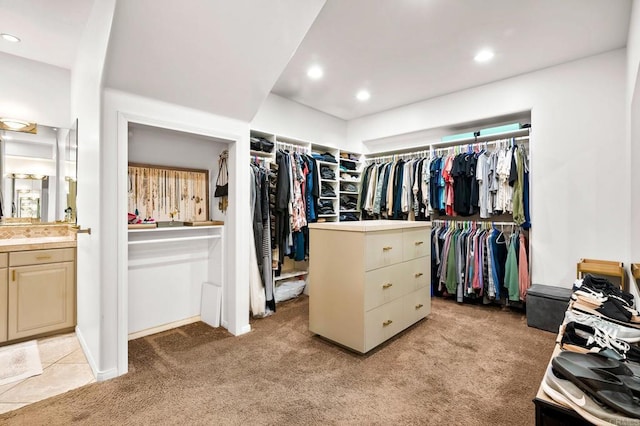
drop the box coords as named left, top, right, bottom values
left=0, top=333, right=96, bottom=413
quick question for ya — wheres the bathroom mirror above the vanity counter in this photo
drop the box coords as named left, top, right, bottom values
left=0, top=121, right=77, bottom=225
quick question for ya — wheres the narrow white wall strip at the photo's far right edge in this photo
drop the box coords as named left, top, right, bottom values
left=627, top=0, right=640, bottom=263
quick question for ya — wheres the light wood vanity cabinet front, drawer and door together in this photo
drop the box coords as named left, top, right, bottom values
left=7, top=248, right=76, bottom=340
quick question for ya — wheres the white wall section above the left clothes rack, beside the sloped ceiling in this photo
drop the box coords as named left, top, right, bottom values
left=251, top=93, right=347, bottom=148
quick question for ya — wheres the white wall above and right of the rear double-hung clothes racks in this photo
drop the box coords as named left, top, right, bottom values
left=348, top=49, right=630, bottom=287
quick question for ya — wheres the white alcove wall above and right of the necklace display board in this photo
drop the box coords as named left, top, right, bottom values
left=129, top=126, right=228, bottom=220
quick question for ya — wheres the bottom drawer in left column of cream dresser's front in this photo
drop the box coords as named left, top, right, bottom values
left=364, top=297, right=406, bottom=352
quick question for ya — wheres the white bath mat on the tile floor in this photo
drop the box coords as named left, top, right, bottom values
left=0, top=340, right=42, bottom=386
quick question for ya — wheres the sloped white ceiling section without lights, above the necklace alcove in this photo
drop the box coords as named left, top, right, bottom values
left=105, top=0, right=324, bottom=122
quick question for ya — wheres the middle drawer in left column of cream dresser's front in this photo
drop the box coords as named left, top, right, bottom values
left=364, top=263, right=414, bottom=312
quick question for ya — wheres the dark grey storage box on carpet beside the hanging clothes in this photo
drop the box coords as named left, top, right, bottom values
left=527, top=284, right=573, bottom=333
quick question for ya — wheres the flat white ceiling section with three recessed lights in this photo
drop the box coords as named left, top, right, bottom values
left=272, top=0, right=631, bottom=120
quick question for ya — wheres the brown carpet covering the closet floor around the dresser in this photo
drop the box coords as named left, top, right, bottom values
left=0, top=296, right=556, bottom=426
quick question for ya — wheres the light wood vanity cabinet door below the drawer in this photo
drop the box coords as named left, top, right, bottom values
left=8, top=262, right=75, bottom=340
